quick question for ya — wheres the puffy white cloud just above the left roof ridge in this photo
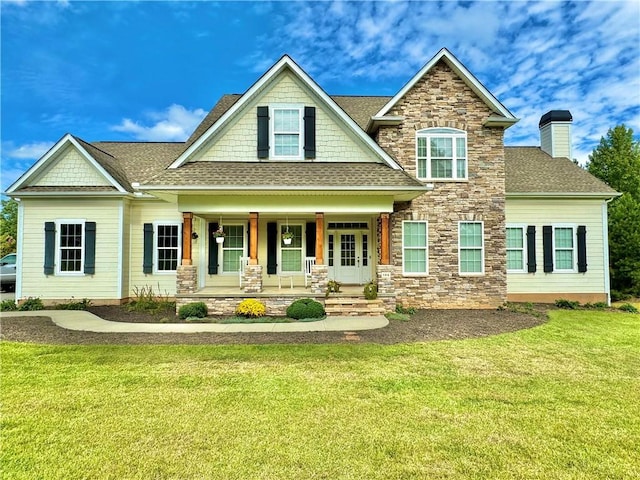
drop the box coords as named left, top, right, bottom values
left=111, top=104, right=207, bottom=142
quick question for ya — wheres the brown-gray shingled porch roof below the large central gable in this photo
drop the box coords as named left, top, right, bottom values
left=146, top=162, right=424, bottom=189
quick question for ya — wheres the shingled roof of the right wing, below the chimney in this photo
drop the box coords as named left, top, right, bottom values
left=504, top=147, right=616, bottom=195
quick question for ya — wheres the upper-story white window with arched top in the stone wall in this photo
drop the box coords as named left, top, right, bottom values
left=416, top=128, right=467, bottom=180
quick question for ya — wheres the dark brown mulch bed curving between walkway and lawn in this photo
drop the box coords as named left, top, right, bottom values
left=0, top=307, right=547, bottom=345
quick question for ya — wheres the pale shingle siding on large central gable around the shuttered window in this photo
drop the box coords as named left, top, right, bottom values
left=194, top=74, right=373, bottom=162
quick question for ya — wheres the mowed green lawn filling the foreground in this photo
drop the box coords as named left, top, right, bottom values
left=1, top=311, right=640, bottom=480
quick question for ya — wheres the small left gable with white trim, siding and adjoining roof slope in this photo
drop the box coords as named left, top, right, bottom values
left=7, top=134, right=128, bottom=194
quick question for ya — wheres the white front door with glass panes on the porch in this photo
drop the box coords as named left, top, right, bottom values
left=329, top=231, right=371, bottom=285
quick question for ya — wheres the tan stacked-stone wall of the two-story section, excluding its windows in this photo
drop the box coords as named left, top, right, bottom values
left=376, top=61, right=507, bottom=308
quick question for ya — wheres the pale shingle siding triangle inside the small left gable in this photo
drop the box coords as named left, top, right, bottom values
left=33, top=146, right=111, bottom=187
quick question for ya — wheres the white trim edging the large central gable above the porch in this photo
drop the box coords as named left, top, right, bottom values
left=169, top=55, right=400, bottom=169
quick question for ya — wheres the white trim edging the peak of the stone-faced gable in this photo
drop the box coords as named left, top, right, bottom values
left=372, top=48, right=518, bottom=127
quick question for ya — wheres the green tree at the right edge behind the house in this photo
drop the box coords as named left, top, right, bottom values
left=587, top=125, right=640, bottom=296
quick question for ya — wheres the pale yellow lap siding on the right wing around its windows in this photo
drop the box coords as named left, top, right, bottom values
left=506, top=198, right=608, bottom=294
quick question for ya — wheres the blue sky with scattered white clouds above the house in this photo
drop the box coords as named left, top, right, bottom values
left=0, top=0, right=640, bottom=191
